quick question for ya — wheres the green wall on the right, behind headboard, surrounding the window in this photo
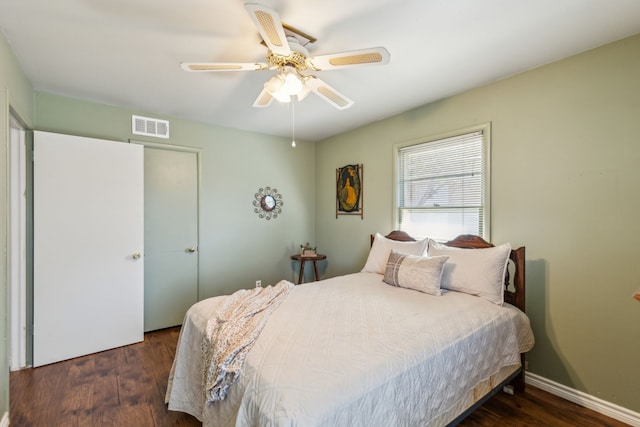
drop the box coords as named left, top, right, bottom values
left=316, top=35, right=640, bottom=412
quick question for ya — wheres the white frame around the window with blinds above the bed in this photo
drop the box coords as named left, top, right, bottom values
left=393, top=123, right=491, bottom=241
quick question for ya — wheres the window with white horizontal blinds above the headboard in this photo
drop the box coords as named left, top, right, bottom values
left=394, top=124, right=490, bottom=241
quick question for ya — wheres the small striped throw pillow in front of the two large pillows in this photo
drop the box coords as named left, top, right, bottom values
left=382, top=249, right=449, bottom=295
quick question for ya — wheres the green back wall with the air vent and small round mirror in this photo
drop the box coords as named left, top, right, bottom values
left=35, top=93, right=315, bottom=298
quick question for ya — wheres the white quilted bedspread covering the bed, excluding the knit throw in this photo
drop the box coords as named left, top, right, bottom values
left=166, top=273, right=533, bottom=426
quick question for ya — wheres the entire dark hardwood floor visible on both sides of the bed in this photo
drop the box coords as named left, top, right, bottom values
left=10, top=328, right=626, bottom=427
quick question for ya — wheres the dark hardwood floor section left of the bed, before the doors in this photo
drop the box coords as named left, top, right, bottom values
left=9, top=328, right=200, bottom=427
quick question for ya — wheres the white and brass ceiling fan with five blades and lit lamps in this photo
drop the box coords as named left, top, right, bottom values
left=180, top=3, right=390, bottom=110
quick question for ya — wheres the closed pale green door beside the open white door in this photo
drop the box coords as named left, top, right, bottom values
left=138, top=143, right=200, bottom=332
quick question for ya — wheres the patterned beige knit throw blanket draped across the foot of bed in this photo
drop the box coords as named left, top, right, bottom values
left=202, top=280, right=294, bottom=402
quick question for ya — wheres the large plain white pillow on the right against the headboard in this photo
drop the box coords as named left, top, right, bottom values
left=427, top=240, right=511, bottom=305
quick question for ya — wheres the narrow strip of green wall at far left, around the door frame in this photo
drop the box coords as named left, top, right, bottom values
left=0, top=30, right=34, bottom=423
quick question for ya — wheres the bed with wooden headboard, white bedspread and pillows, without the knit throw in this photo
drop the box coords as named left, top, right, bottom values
left=166, top=231, right=534, bottom=427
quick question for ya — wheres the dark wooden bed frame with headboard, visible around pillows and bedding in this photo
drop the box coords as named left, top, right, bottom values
left=371, top=230, right=526, bottom=398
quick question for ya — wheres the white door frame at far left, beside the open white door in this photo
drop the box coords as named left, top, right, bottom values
left=7, top=113, right=27, bottom=371
